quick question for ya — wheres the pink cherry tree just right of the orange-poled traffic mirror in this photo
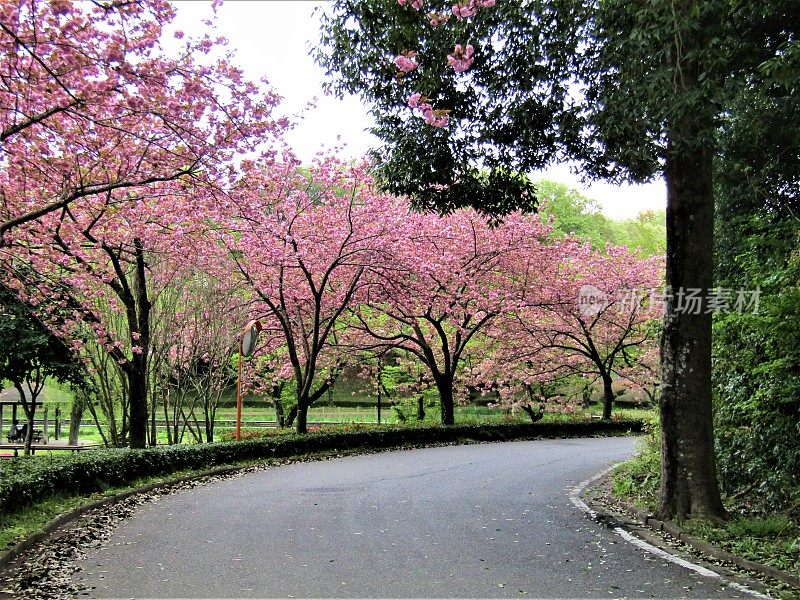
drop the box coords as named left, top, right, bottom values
left=210, top=159, right=408, bottom=433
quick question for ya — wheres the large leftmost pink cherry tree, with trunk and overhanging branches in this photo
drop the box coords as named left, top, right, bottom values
left=0, top=0, right=283, bottom=447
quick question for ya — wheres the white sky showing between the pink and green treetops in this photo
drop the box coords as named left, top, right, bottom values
left=175, top=0, right=666, bottom=219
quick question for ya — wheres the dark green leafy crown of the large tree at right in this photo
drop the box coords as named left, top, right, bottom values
left=315, top=0, right=800, bottom=212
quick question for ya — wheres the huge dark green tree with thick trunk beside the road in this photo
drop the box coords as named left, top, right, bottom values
left=317, top=0, right=800, bottom=519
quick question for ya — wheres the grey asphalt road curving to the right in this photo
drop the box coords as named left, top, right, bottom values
left=76, top=438, right=760, bottom=598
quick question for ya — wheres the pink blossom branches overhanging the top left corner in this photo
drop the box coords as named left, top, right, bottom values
left=0, top=0, right=276, bottom=246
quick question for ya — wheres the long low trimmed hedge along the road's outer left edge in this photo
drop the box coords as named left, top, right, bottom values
left=0, top=421, right=642, bottom=514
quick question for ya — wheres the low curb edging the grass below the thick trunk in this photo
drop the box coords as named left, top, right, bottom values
left=580, top=467, right=800, bottom=589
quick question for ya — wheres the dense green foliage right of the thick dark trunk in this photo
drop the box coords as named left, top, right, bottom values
left=713, top=74, right=800, bottom=511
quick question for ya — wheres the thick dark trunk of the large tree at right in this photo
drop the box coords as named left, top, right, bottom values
left=658, top=126, right=725, bottom=520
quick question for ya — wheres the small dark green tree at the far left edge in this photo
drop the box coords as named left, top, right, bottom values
left=0, top=283, right=82, bottom=454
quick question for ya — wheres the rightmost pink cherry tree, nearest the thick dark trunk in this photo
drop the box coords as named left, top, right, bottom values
left=497, top=241, right=663, bottom=419
